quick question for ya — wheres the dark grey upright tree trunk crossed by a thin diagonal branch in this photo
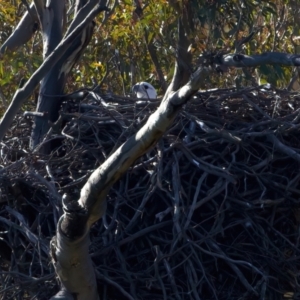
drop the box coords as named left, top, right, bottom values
left=31, top=0, right=95, bottom=153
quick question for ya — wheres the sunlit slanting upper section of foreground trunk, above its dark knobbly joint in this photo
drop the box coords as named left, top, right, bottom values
left=79, top=68, right=210, bottom=225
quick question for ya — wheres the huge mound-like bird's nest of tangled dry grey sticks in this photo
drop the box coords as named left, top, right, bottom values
left=0, top=87, right=300, bottom=300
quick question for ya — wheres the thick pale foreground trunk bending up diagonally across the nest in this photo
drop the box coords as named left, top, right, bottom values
left=51, top=68, right=210, bottom=300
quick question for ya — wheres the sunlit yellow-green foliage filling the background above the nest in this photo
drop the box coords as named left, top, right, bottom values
left=0, top=0, right=300, bottom=104
